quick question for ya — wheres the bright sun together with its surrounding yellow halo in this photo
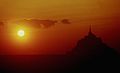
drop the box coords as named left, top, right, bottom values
left=10, top=23, right=32, bottom=43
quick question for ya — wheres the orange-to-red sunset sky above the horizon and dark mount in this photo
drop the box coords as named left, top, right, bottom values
left=0, top=0, right=120, bottom=54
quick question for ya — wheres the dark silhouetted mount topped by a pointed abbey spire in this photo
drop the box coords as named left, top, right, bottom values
left=71, top=26, right=117, bottom=57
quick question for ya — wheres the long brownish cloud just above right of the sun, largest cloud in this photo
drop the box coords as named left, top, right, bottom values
left=24, top=19, right=57, bottom=28
